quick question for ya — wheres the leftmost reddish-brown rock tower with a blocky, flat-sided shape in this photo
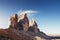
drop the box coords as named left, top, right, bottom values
left=9, top=14, right=18, bottom=29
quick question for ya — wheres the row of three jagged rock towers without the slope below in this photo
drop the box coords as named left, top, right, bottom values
left=9, top=13, right=38, bottom=33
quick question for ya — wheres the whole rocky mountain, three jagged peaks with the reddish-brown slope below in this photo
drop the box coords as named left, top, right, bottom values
left=0, top=13, right=51, bottom=40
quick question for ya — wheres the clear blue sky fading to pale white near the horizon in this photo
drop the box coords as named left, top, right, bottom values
left=0, top=0, right=60, bottom=35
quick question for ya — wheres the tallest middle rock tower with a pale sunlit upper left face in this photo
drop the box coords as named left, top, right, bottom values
left=18, top=13, right=29, bottom=31
